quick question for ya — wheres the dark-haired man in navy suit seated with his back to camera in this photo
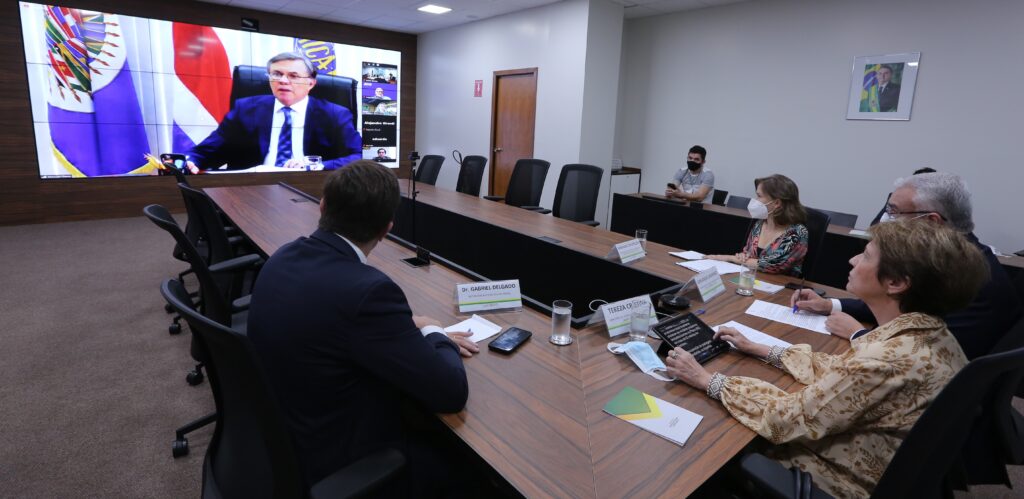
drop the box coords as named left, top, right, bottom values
left=248, top=160, right=478, bottom=494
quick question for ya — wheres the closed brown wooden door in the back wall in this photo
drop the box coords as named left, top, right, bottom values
left=489, top=68, right=537, bottom=196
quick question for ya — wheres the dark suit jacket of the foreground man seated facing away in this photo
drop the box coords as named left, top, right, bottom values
left=249, top=231, right=469, bottom=483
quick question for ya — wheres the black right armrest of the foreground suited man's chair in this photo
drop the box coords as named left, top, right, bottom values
left=309, top=449, right=406, bottom=499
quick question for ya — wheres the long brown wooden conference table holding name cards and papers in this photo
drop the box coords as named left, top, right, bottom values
left=205, top=182, right=849, bottom=497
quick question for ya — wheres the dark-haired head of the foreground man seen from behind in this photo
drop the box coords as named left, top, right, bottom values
left=319, top=160, right=399, bottom=244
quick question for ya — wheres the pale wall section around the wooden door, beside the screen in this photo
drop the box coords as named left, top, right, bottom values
left=416, top=0, right=593, bottom=208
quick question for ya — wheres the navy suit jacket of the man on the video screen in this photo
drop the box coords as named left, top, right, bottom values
left=187, top=95, right=362, bottom=170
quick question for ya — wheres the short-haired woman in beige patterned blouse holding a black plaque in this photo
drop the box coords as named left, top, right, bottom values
left=666, top=220, right=988, bottom=497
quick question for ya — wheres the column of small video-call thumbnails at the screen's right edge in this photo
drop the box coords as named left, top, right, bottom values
left=362, top=61, right=398, bottom=167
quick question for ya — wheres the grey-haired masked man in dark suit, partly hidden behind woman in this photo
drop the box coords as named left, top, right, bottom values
left=791, top=172, right=1021, bottom=359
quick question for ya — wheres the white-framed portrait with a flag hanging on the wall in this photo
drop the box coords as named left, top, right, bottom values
left=846, top=52, right=921, bottom=120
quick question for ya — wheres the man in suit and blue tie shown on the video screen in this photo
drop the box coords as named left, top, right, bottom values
left=186, top=52, right=362, bottom=170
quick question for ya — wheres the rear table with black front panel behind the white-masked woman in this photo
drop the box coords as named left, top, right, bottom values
left=610, top=193, right=1024, bottom=287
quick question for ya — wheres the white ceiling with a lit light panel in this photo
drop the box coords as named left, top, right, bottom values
left=200, top=0, right=746, bottom=33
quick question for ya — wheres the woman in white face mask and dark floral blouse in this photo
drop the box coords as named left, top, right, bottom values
left=708, top=174, right=807, bottom=276
